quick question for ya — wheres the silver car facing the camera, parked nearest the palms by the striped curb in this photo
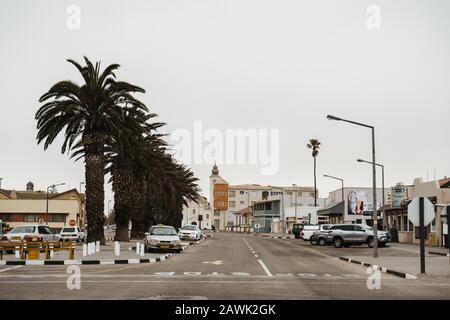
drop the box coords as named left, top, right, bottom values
left=144, top=225, right=181, bottom=252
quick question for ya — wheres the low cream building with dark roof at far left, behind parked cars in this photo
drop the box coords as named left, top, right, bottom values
left=0, top=182, right=85, bottom=232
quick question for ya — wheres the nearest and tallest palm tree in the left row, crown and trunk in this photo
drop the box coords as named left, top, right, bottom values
left=35, top=57, right=147, bottom=243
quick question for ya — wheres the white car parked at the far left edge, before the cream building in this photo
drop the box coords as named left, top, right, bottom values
left=2, top=224, right=61, bottom=241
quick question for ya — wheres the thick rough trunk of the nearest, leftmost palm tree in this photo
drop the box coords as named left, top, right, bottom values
left=85, top=135, right=105, bottom=244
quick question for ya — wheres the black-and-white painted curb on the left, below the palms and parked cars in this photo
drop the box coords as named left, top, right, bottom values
left=0, top=253, right=172, bottom=266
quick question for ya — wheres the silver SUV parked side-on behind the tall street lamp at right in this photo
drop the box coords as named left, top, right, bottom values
left=326, top=224, right=391, bottom=248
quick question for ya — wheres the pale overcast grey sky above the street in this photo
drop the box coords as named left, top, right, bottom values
left=0, top=0, right=450, bottom=210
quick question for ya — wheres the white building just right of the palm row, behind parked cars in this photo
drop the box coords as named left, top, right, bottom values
left=182, top=197, right=213, bottom=229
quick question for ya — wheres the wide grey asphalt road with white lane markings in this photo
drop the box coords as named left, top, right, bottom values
left=0, top=233, right=450, bottom=300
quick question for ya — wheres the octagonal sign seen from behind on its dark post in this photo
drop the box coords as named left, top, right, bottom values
left=408, top=197, right=435, bottom=273
